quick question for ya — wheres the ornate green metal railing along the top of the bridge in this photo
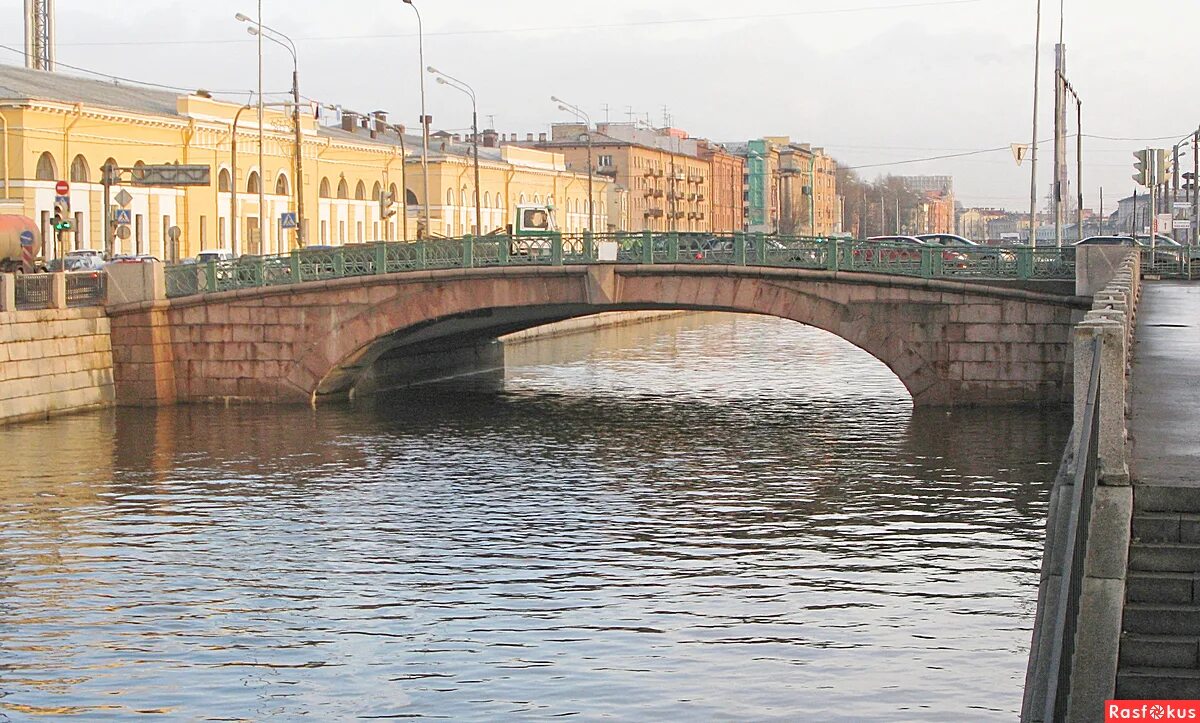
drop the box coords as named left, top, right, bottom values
left=167, top=232, right=1075, bottom=298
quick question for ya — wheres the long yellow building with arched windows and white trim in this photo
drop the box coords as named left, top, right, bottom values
left=0, top=65, right=607, bottom=261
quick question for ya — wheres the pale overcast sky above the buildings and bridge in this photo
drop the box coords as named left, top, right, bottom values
left=0, top=0, right=1200, bottom=211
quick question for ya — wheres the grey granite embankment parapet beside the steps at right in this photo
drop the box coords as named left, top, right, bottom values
left=1021, top=247, right=1141, bottom=723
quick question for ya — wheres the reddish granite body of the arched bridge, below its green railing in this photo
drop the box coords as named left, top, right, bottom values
left=110, top=264, right=1088, bottom=406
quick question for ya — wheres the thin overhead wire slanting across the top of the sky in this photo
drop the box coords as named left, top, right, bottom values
left=46, top=0, right=1000, bottom=47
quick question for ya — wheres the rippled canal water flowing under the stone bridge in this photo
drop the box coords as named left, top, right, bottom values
left=0, top=315, right=1068, bottom=721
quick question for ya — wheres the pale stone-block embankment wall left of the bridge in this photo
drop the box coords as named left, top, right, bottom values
left=0, top=274, right=115, bottom=424
